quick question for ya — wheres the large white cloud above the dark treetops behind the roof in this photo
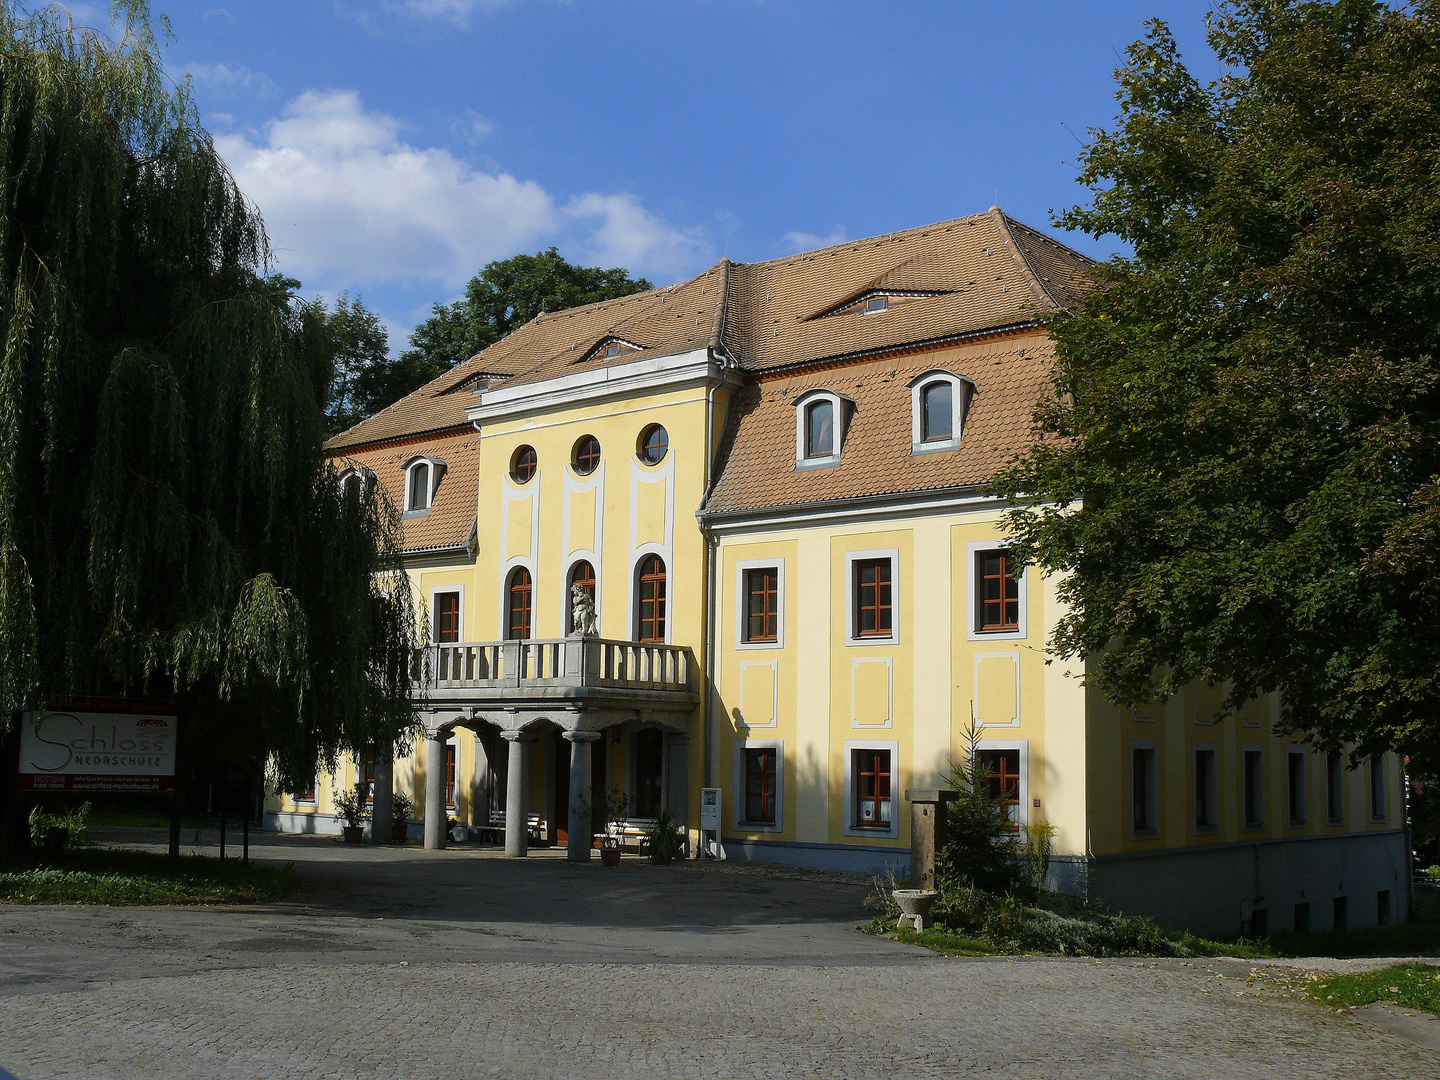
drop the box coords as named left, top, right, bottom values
left=215, top=91, right=708, bottom=292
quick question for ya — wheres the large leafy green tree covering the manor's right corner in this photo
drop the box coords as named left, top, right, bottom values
left=999, top=0, right=1440, bottom=753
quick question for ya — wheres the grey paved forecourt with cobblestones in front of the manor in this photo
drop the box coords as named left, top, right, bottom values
left=0, top=841, right=1440, bottom=1080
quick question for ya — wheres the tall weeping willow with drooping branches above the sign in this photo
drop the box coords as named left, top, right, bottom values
left=0, top=0, right=418, bottom=785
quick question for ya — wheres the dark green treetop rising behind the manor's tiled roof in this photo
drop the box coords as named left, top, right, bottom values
left=403, top=248, right=654, bottom=377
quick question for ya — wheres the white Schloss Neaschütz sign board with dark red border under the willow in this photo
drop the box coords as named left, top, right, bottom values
left=20, top=701, right=176, bottom=792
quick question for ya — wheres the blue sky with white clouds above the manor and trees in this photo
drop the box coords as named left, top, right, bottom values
left=68, top=0, right=1215, bottom=348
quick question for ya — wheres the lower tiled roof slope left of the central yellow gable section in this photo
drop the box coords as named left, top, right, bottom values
left=334, top=429, right=480, bottom=552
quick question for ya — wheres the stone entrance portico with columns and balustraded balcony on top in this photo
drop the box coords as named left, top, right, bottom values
left=391, top=635, right=700, bottom=860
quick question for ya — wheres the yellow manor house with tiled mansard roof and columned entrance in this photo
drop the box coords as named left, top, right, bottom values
left=268, top=207, right=1410, bottom=935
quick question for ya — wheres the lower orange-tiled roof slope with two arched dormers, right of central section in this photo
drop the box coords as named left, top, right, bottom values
left=704, top=333, right=1056, bottom=514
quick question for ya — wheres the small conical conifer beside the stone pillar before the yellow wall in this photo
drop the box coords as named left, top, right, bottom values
left=936, top=717, right=1024, bottom=893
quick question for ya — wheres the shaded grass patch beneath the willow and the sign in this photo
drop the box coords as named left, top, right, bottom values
left=0, top=848, right=300, bottom=904
